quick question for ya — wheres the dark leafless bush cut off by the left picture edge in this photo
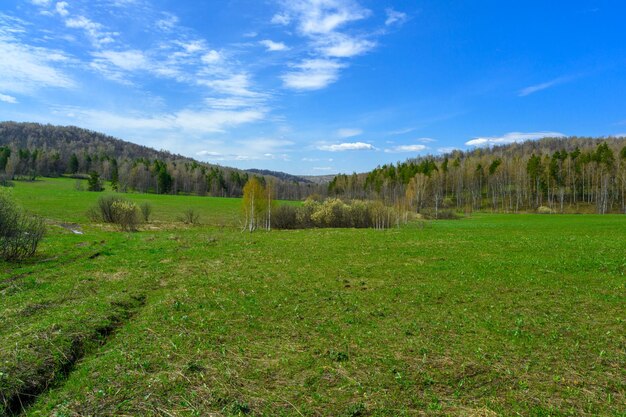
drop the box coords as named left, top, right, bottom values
left=0, top=190, right=46, bottom=261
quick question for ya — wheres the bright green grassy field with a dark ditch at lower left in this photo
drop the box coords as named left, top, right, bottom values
left=0, top=179, right=626, bottom=417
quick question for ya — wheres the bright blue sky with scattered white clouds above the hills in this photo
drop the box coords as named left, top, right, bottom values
left=0, top=0, right=626, bottom=175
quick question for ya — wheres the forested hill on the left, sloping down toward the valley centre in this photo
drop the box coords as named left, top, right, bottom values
left=0, top=122, right=326, bottom=199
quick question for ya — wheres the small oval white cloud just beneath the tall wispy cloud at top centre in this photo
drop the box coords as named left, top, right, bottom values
left=281, top=59, right=345, bottom=90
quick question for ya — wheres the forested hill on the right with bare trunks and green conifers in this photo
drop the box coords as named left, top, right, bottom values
left=329, top=137, right=626, bottom=213
